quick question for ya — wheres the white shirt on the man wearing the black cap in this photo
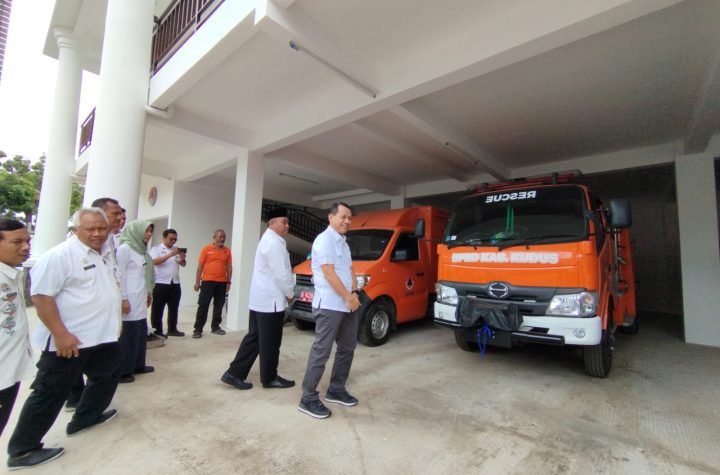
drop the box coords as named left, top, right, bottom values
left=249, top=229, right=294, bottom=313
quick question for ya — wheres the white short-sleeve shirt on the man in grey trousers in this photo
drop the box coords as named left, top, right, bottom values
left=312, top=226, right=353, bottom=312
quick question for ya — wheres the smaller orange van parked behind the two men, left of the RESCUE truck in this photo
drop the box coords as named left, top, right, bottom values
left=288, top=206, right=448, bottom=346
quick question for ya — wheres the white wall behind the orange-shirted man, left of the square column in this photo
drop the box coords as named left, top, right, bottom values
left=169, top=182, right=237, bottom=310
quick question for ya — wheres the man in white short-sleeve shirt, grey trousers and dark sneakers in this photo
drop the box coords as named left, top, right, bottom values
left=298, top=203, right=360, bottom=419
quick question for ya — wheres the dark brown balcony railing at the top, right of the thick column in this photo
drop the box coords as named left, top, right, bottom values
left=152, top=0, right=223, bottom=74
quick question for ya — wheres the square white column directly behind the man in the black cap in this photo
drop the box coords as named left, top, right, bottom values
left=227, top=151, right=265, bottom=330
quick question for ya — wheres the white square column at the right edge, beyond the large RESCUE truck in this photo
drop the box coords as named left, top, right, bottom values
left=675, top=154, right=720, bottom=346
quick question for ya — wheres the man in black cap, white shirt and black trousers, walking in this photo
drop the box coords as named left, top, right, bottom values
left=220, top=208, right=295, bottom=389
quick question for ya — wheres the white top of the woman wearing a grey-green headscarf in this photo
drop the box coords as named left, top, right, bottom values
left=117, top=244, right=147, bottom=321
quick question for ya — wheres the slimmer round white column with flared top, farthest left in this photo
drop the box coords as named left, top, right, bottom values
left=32, top=28, right=82, bottom=260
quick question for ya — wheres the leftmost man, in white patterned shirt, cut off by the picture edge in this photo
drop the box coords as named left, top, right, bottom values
left=0, top=219, right=34, bottom=435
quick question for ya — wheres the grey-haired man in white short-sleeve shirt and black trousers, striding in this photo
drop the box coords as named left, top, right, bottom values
left=7, top=208, right=123, bottom=469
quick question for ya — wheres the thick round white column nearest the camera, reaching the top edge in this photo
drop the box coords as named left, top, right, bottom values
left=84, top=0, right=155, bottom=220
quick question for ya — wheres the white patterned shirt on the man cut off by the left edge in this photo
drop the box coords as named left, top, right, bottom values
left=0, top=262, right=35, bottom=389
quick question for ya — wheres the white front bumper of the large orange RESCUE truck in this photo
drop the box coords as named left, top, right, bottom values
left=435, top=302, right=602, bottom=346
